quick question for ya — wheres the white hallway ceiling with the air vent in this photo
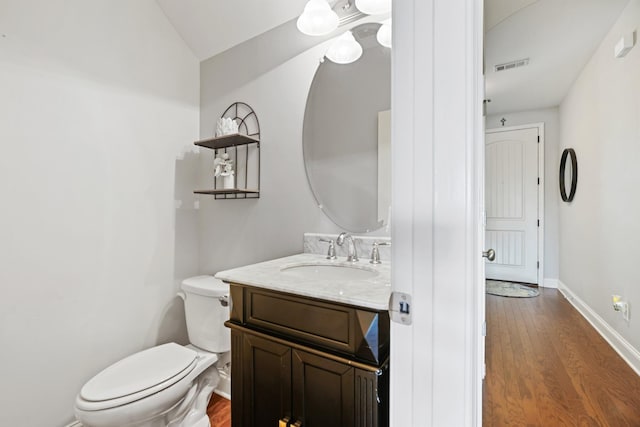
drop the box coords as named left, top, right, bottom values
left=485, top=0, right=629, bottom=114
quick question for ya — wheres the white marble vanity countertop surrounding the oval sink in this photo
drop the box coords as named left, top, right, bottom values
left=215, top=253, right=391, bottom=310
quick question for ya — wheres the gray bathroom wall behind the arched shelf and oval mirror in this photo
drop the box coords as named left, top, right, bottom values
left=198, top=21, right=388, bottom=273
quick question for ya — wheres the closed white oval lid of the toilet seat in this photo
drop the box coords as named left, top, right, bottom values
left=80, top=343, right=198, bottom=402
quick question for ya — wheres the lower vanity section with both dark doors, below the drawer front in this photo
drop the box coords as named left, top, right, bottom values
left=230, top=324, right=389, bottom=427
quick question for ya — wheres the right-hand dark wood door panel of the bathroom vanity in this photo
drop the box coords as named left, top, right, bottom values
left=292, top=350, right=354, bottom=427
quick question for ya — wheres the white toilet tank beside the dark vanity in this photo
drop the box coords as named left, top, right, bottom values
left=182, top=276, right=231, bottom=353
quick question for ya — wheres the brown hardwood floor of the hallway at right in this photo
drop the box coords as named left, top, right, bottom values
left=483, top=288, right=640, bottom=427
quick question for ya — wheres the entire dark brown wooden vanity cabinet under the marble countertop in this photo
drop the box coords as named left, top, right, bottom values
left=227, top=285, right=389, bottom=427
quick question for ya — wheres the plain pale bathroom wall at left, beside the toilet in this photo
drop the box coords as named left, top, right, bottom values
left=0, top=0, right=200, bottom=427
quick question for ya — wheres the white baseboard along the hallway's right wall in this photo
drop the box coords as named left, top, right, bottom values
left=558, top=280, right=640, bottom=375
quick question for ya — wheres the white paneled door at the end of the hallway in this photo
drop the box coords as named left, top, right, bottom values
left=485, top=127, right=540, bottom=284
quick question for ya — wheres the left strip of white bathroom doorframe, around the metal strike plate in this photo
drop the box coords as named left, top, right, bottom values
left=389, top=0, right=434, bottom=427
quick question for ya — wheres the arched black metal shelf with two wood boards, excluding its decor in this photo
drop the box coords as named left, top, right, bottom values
left=194, top=102, right=260, bottom=199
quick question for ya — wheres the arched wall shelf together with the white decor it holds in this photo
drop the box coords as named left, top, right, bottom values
left=194, top=102, right=260, bottom=199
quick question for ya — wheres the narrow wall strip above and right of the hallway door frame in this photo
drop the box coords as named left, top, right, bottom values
left=485, top=107, right=560, bottom=280
